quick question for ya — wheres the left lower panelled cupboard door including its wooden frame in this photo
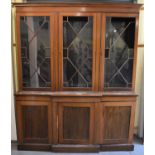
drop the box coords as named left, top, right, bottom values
left=16, top=101, right=52, bottom=144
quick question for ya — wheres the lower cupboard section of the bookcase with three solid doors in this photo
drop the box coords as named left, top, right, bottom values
left=16, top=96, right=136, bottom=152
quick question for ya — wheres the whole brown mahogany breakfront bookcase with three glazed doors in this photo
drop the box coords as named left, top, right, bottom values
left=13, top=3, right=141, bottom=152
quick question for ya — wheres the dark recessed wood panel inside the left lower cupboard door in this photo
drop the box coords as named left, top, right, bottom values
left=22, top=106, right=48, bottom=142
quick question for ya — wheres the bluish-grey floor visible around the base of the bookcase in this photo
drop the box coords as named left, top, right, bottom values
left=11, top=141, right=144, bottom=155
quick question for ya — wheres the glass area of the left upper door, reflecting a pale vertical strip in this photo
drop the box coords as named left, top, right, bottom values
left=20, top=16, right=51, bottom=88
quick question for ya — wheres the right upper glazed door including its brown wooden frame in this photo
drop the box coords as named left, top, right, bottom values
left=100, top=13, right=138, bottom=90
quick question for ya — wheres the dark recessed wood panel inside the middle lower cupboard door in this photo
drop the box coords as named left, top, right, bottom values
left=63, top=107, right=90, bottom=140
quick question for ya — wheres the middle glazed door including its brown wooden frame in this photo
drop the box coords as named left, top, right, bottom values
left=59, top=13, right=96, bottom=90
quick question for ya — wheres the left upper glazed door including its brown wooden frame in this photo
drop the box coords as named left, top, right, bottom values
left=16, top=12, right=55, bottom=90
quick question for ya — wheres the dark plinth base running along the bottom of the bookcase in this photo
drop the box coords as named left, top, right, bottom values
left=18, top=144, right=134, bottom=153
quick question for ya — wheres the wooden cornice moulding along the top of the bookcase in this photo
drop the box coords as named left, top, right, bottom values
left=12, top=3, right=143, bottom=13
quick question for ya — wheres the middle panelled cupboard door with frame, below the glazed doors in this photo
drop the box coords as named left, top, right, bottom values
left=58, top=103, right=94, bottom=144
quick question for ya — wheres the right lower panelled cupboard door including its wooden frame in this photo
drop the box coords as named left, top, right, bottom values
left=103, top=102, right=134, bottom=144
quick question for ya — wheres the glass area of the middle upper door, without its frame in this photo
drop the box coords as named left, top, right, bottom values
left=63, top=16, right=93, bottom=87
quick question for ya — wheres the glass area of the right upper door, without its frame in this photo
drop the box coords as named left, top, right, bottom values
left=104, top=17, right=135, bottom=88
